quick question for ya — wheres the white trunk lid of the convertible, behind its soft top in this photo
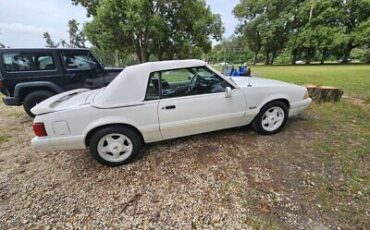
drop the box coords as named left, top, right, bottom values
left=31, top=89, right=100, bottom=115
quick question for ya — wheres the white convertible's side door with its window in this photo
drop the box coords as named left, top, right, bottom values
left=158, top=67, right=246, bottom=139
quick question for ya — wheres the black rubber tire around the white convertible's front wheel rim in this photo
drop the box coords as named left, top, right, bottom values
left=251, top=101, right=289, bottom=135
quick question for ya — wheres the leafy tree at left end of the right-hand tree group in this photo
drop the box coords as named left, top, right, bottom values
left=233, top=0, right=292, bottom=64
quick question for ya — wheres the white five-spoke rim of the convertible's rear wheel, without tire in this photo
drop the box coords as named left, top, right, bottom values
left=97, top=133, right=133, bottom=162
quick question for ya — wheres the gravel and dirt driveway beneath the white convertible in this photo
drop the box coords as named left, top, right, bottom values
left=0, top=101, right=368, bottom=229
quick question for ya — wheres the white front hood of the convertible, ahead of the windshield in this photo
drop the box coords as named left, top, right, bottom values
left=231, top=77, right=294, bottom=88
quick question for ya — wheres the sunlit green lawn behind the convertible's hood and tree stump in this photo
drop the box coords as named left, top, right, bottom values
left=251, top=65, right=370, bottom=99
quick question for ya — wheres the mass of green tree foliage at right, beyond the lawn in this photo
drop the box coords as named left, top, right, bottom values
left=234, top=0, right=370, bottom=64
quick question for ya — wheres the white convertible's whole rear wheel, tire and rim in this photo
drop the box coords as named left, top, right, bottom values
left=89, top=127, right=142, bottom=166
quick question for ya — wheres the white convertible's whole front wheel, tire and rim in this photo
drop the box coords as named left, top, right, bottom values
left=252, top=101, right=288, bottom=135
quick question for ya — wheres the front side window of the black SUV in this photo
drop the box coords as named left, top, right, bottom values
left=62, top=51, right=97, bottom=70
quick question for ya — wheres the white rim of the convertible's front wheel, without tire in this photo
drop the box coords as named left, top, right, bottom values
left=261, top=106, right=285, bottom=132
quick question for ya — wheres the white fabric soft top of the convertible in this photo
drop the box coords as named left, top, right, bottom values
left=92, top=59, right=207, bottom=108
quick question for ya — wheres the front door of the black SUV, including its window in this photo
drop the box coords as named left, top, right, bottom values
left=61, top=50, right=105, bottom=90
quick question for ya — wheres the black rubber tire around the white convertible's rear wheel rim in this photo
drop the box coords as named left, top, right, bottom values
left=89, top=126, right=143, bottom=167
